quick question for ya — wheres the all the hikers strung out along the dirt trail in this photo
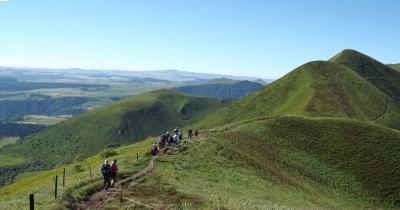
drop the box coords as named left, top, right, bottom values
left=101, top=127, right=199, bottom=191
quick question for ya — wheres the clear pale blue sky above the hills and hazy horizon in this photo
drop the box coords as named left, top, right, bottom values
left=0, top=0, right=400, bottom=78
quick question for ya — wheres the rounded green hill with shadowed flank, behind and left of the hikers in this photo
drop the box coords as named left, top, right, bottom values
left=0, top=90, right=229, bottom=184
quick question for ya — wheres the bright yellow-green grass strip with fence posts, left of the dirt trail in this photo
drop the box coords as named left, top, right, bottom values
left=0, top=139, right=152, bottom=209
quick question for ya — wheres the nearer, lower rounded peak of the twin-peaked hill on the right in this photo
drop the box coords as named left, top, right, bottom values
left=198, top=61, right=387, bottom=125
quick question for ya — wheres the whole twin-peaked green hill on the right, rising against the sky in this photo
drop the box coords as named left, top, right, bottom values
left=198, top=50, right=400, bottom=129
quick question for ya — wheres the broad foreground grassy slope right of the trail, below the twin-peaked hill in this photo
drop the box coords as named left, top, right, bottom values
left=101, top=116, right=400, bottom=209
